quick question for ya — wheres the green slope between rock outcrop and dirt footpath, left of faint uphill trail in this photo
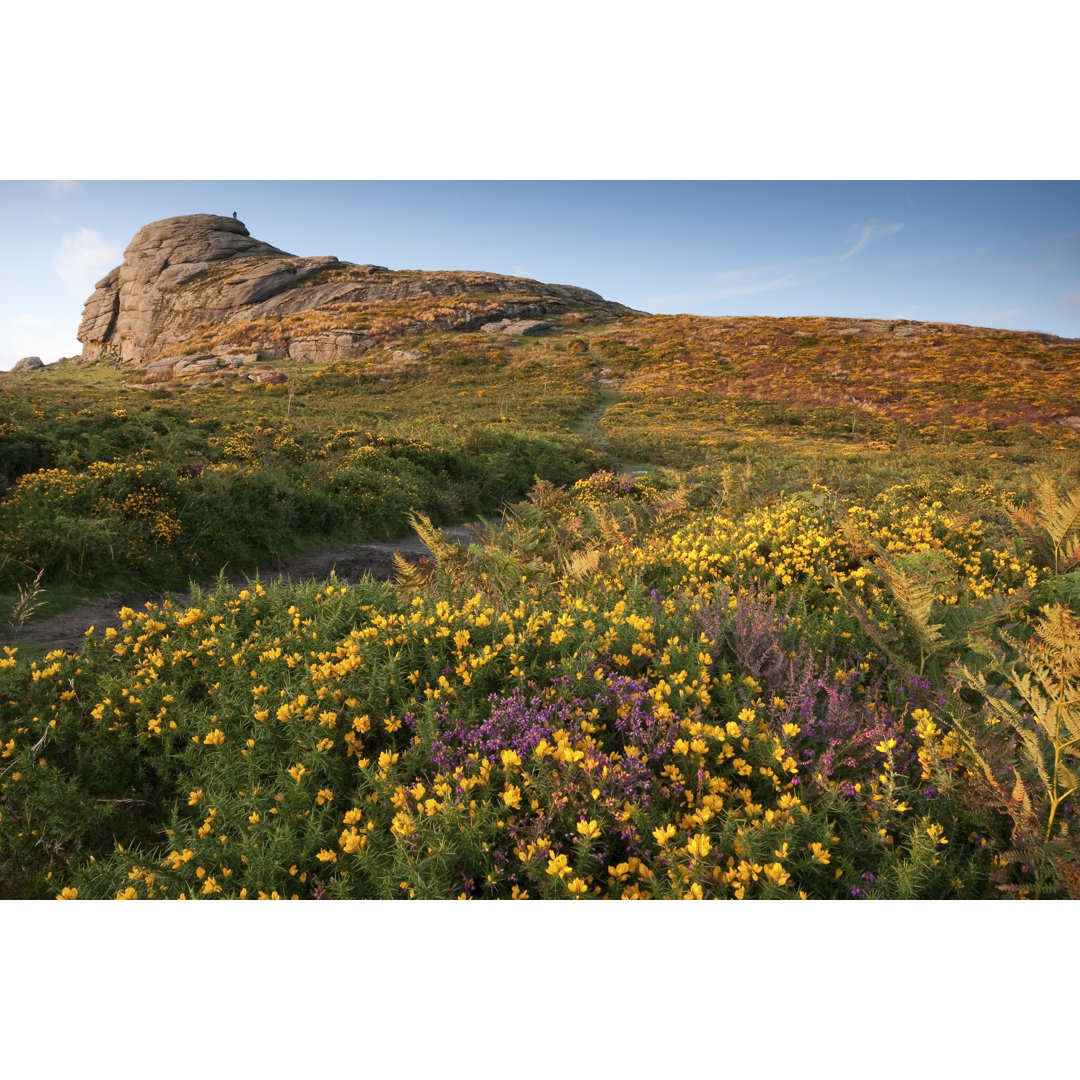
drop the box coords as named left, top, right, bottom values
left=0, top=335, right=604, bottom=597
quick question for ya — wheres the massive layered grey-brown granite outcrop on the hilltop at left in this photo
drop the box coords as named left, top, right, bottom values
left=79, top=214, right=630, bottom=366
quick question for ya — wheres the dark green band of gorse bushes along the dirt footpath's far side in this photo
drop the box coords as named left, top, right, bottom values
left=0, top=428, right=583, bottom=584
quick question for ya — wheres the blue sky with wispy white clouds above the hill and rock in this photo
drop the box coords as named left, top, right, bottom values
left=0, top=180, right=1080, bottom=369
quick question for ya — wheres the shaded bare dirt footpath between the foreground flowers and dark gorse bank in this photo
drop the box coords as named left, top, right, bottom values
left=0, top=525, right=486, bottom=651
